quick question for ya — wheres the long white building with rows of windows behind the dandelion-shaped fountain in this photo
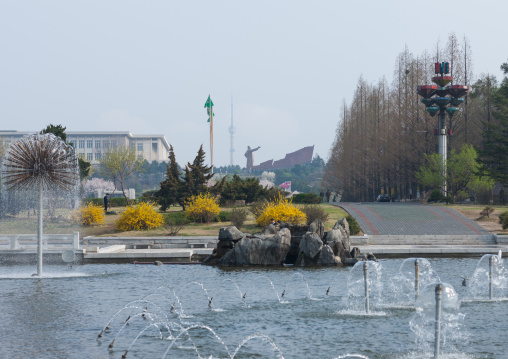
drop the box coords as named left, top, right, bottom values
left=0, top=131, right=169, bottom=165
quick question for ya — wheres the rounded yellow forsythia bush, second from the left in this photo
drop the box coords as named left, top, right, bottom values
left=116, top=202, right=164, bottom=231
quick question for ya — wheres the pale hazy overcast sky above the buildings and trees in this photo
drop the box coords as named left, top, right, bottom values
left=0, top=0, right=508, bottom=167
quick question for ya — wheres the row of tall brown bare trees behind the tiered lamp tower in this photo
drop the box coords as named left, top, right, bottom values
left=324, top=33, right=508, bottom=201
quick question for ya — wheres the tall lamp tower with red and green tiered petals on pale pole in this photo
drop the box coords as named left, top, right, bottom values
left=417, top=62, right=469, bottom=196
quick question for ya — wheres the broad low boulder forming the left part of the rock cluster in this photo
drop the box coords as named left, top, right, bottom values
left=218, top=228, right=291, bottom=267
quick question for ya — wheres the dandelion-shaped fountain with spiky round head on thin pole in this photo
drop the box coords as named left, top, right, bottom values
left=2, top=134, right=79, bottom=276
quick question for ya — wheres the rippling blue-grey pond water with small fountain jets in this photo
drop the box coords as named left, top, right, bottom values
left=0, top=258, right=508, bottom=359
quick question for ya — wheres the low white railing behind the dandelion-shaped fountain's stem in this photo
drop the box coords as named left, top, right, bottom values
left=0, top=232, right=79, bottom=250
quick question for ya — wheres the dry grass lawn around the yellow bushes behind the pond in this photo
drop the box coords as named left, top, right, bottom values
left=0, top=204, right=347, bottom=238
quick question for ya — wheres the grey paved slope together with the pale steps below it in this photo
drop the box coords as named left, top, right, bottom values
left=334, top=202, right=508, bottom=258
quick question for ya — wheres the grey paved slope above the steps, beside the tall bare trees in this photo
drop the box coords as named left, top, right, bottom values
left=336, top=202, right=490, bottom=235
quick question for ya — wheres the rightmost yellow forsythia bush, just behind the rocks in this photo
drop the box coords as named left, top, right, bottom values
left=256, top=194, right=307, bottom=227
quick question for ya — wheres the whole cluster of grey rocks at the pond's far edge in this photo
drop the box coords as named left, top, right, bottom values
left=203, top=218, right=376, bottom=267
